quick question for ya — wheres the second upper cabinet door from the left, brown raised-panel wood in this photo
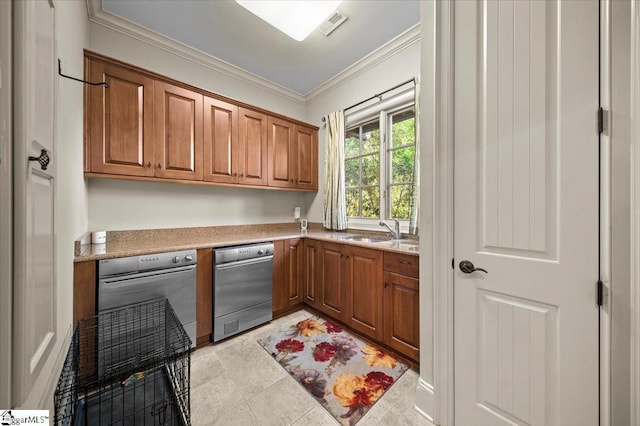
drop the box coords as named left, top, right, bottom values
left=154, top=81, right=203, bottom=180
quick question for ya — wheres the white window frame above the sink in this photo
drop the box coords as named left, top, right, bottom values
left=344, top=100, right=417, bottom=233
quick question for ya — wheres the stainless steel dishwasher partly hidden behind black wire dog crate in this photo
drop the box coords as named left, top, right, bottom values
left=98, top=250, right=198, bottom=347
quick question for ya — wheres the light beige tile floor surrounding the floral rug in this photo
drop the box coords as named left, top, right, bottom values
left=191, top=311, right=432, bottom=426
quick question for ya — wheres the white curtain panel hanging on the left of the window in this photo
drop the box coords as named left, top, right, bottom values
left=324, top=111, right=347, bottom=231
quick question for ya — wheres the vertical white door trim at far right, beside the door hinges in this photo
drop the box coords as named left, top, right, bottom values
left=609, top=1, right=632, bottom=425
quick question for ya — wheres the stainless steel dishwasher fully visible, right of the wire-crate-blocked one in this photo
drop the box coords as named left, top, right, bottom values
left=213, top=242, right=273, bottom=342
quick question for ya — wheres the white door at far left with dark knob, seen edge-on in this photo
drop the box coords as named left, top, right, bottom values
left=12, top=0, right=57, bottom=408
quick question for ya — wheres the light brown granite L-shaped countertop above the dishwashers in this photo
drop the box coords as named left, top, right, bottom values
left=74, top=223, right=419, bottom=262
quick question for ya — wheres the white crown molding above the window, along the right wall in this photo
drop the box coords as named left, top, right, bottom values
left=304, top=23, right=420, bottom=104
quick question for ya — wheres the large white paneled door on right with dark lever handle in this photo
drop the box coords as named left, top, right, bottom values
left=454, top=0, right=599, bottom=426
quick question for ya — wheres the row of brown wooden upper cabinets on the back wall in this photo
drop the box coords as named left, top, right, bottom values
left=85, top=52, right=318, bottom=191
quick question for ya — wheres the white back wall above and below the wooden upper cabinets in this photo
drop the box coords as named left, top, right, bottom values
left=88, top=23, right=315, bottom=230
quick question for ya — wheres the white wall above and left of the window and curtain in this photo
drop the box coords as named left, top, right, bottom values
left=306, top=42, right=420, bottom=222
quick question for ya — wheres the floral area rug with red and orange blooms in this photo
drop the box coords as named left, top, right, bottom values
left=258, top=317, right=409, bottom=425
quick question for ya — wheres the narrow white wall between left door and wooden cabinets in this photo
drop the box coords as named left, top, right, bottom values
left=17, top=1, right=88, bottom=415
